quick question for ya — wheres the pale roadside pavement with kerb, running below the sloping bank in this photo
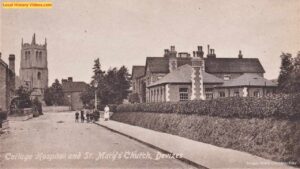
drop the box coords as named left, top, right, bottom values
left=96, top=119, right=294, bottom=169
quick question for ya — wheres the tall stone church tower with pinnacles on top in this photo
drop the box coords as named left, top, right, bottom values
left=20, top=34, right=48, bottom=99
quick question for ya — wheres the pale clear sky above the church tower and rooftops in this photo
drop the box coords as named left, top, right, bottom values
left=0, top=0, right=300, bottom=85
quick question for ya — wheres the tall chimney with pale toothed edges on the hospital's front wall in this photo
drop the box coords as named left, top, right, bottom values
left=191, top=48, right=205, bottom=100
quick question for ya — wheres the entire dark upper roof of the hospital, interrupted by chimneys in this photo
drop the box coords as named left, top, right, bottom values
left=146, top=57, right=265, bottom=73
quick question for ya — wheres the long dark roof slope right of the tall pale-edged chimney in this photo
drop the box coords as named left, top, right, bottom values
left=205, top=58, right=265, bottom=73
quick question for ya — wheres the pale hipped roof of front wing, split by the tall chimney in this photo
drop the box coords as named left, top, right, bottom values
left=148, top=64, right=223, bottom=87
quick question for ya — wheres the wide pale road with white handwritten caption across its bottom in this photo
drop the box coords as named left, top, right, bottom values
left=0, top=112, right=195, bottom=169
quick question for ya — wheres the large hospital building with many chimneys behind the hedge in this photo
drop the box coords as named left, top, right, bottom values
left=132, top=45, right=276, bottom=102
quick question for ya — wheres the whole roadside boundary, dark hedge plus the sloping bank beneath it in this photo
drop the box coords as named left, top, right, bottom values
left=112, top=95, right=300, bottom=165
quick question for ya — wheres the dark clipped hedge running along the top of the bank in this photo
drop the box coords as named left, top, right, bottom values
left=116, top=94, right=300, bottom=119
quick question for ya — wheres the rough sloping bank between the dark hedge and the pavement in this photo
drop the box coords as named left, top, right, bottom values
left=111, top=112, right=300, bottom=167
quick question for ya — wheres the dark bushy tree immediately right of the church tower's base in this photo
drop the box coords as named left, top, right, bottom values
left=44, top=79, right=64, bottom=106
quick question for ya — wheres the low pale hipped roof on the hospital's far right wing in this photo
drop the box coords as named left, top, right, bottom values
left=219, top=73, right=277, bottom=87
